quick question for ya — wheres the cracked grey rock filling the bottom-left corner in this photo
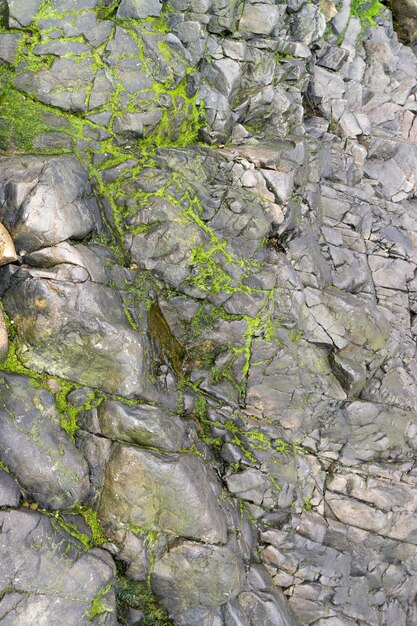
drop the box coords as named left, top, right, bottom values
left=0, top=510, right=117, bottom=626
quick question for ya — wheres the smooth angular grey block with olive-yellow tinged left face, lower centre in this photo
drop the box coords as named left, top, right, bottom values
left=99, top=444, right=227, bottom=543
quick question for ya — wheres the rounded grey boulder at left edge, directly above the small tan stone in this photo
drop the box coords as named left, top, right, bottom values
left=0, top=155, right=94, bottom=252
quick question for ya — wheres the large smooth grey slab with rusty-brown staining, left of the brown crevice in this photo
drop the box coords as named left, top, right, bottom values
left=4, top=275, right=154, bottom=399
